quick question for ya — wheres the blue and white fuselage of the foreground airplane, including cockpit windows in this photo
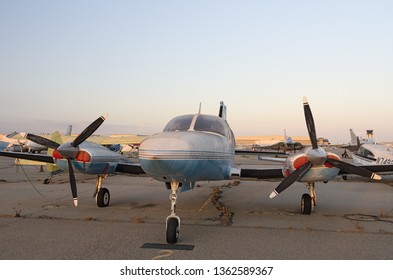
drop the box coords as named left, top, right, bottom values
left=139, top=114, right=235, bottom=183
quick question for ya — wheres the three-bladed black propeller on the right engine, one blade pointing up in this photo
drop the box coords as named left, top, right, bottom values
left=270, top=97, right=382, bottom=198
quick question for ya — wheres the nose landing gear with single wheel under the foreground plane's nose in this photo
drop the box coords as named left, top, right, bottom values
left=166, top=181, right=180, bottom=244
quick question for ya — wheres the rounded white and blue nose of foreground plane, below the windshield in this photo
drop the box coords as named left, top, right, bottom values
left=139, top=131, right=233, bottom=182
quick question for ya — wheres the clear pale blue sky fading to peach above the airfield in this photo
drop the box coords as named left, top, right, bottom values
left=0, top=0, right=393, bottom=143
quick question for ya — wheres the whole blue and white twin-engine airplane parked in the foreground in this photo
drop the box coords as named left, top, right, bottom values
left=0, top=100, right=393, bottom=244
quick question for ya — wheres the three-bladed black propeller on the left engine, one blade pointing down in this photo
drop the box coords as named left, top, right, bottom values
left=24, top=114, right=108, bottom=206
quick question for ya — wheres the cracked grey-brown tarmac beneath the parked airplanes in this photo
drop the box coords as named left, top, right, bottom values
left=0, top=153, right=393, bottom=260
